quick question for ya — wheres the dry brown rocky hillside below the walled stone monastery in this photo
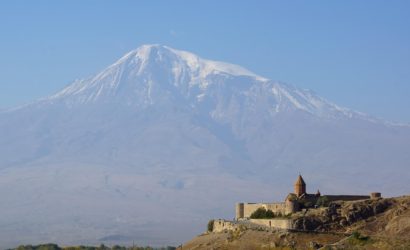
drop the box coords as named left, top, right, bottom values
left=183, top=196, right=410, bottom=249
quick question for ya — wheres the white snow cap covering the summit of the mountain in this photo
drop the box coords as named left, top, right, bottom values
left=48, top=45, right=266, bottom=101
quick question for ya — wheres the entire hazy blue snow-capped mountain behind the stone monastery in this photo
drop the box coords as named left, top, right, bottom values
left=0, top=45, right=410, bottom=246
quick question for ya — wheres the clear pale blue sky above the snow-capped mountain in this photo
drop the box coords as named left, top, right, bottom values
left=0, top=0, right=410, bottom=122
